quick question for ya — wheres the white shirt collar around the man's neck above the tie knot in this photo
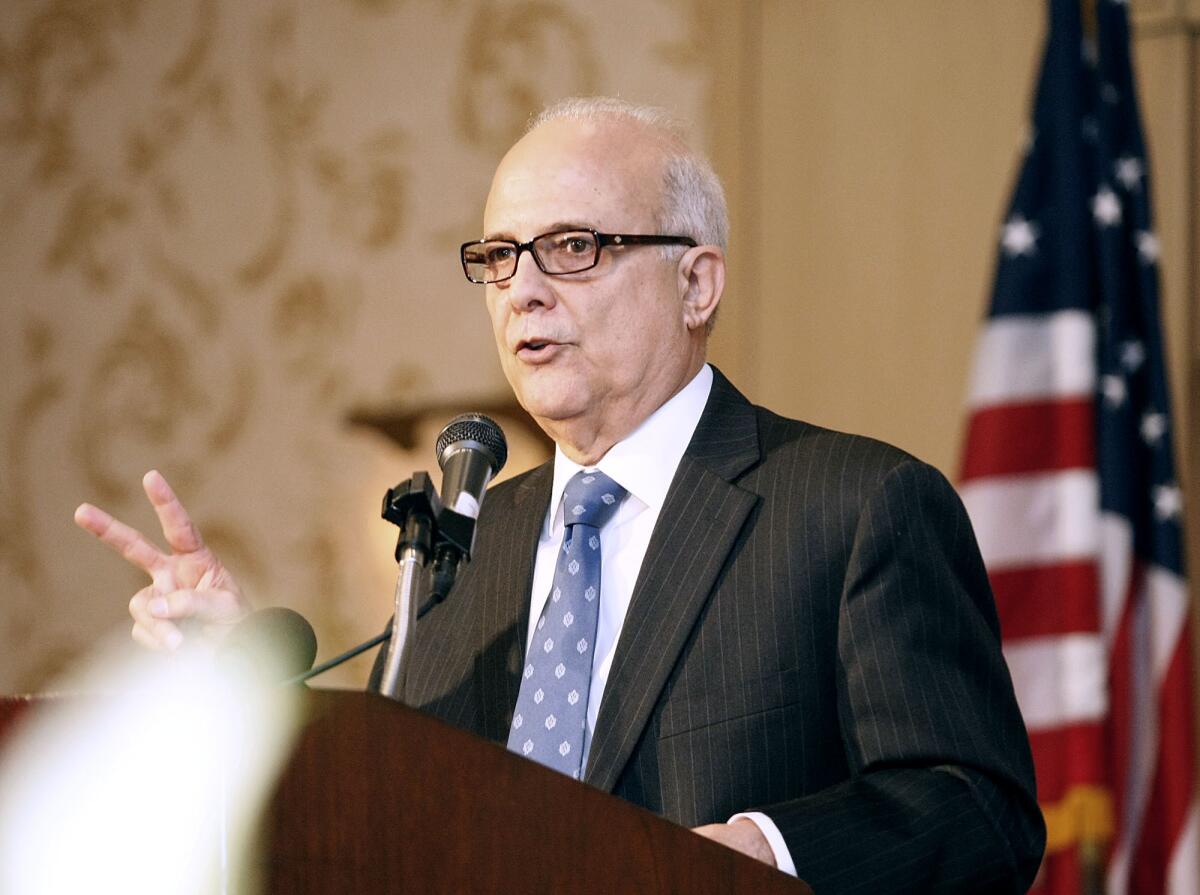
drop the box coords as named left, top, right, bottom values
left=546, top=364, right=713, bottom=535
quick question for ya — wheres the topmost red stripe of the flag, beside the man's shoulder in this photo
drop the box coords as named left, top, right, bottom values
left=961, top=398, right=1096, bottom=482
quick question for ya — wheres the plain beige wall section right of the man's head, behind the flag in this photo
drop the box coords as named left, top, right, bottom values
left=715, top=0, right=1198, bottom=477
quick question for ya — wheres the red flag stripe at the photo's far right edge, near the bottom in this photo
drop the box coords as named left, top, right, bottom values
left=1129, top=626, right=1193, bottom=893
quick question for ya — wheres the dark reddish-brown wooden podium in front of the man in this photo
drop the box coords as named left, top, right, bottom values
left=0, top=690, right=810, bottom=895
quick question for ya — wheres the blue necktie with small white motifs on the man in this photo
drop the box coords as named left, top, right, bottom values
left=509, top=471, right=625, bottom=780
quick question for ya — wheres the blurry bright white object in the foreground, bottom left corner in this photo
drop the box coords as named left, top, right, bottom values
left=0, top=643, right=296, bottom=895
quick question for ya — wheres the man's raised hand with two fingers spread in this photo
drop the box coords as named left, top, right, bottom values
left=74, top=470, right=250, bottom=650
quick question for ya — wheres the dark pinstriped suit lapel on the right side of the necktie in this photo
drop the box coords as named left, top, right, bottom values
left=586, top=371, right=760, bottom=791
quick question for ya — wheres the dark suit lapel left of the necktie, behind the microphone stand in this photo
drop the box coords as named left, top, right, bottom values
left=479, top=463, right=554, bottom=743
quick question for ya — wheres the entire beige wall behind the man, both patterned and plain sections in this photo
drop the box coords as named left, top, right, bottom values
left=0, top=0, right=1200, bottom=691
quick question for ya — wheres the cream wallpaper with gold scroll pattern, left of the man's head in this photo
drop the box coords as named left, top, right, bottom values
left=0, top=0, right=714, bottom=692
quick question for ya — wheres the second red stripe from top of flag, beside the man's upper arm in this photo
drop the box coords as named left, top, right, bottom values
left=988, top=560, right=1100, bottom=641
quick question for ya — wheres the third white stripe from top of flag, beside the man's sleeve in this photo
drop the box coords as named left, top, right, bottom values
left=1004, top=633, right=1109, bottom=732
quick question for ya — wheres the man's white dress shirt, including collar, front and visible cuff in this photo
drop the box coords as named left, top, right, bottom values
left=526, top=364, right=796, bottom=876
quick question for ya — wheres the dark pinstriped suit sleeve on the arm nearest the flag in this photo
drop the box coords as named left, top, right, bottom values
left=757, top=459, right=1045, bottom=895
